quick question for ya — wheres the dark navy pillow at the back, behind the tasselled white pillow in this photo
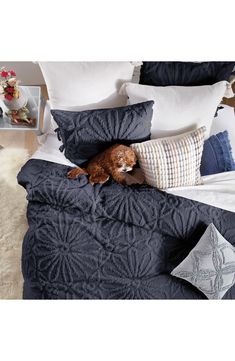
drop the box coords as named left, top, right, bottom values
left=140, top=61, right=235, bottom=86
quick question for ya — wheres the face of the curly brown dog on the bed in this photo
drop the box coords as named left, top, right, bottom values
left=113, top=146, right=137, bottom=173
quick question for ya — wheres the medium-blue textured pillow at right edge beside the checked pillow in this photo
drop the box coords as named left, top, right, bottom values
left=200, top=130, right=235, bottom=176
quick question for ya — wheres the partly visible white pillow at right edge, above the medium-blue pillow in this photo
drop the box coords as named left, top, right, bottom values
left=210, top=104, right=235, bottom=159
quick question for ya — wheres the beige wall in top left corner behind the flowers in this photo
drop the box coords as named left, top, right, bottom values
left=0, top=61, right=45, bottom=85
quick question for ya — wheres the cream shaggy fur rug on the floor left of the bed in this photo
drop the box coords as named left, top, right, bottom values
left=0, top=148, right=29, bottom=299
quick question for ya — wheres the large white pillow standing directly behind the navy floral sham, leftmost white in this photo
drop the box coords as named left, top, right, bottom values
left=39, top=61, right=136, bottom=110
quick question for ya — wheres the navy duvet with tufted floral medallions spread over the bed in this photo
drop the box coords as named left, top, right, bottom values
left=18, top=159, right=235, bottom=299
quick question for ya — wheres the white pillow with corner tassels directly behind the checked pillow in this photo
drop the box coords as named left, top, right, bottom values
left=120, top=81, right=231, bottom=139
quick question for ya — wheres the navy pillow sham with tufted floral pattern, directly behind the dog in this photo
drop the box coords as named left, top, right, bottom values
left=51, top=101, right=154, bottom=166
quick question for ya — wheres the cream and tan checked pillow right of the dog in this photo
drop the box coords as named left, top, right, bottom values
left=131, top=127, right=206, bottom=189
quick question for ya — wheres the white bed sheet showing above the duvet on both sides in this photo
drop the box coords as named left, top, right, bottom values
left=32, top=134, right=235, bottom=212
